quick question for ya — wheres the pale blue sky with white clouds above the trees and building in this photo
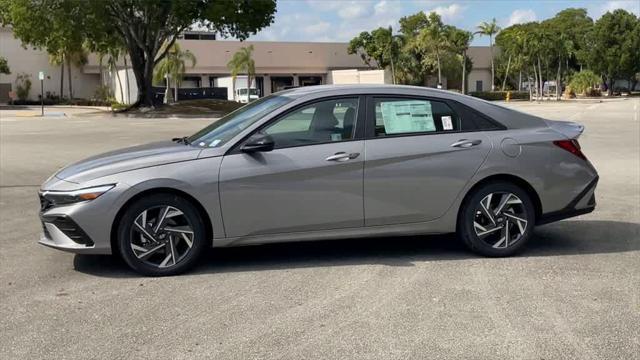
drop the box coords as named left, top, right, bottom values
left=248, top=0, right=640, bottom=46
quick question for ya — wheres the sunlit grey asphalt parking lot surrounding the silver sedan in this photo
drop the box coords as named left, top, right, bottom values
left=0, top=98, right=640, bottom=359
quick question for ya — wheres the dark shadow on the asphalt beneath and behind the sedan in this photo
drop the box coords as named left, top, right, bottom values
left=74, top=220, right=640, bottom=278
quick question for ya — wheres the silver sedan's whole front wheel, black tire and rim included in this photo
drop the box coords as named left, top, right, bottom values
left=117, top=194, right=207, bottom=276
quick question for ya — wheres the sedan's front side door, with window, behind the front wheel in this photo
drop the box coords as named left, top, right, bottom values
left=219, top=97, right=364, bottom=237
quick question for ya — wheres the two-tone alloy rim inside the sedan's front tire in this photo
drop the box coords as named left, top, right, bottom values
left=130, top=206, right=194, bottom=268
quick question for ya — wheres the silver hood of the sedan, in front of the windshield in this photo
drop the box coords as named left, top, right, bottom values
left=55, top=141, right=202, bottom=183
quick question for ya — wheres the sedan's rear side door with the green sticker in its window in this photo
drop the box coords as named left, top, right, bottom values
left=364, top=96, right=491, bottom=226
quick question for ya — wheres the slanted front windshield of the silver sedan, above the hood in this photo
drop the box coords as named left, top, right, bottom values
left=187, top=95, right=293, bottom=147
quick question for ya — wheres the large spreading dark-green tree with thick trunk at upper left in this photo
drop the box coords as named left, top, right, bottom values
left=0, top=0, right=276, bottom=106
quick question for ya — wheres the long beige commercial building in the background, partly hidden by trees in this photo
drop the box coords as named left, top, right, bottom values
left=0, top=28, right=491, bottom=103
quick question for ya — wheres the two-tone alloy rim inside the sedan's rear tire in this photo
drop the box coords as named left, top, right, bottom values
left=473, top=192, right=528, bottom=249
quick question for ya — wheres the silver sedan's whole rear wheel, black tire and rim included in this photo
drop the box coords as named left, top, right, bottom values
left=457, top=181, right=535, bottom=257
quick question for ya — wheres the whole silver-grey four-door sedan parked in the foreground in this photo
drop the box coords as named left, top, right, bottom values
left=40, top=85, right=598, bottom=276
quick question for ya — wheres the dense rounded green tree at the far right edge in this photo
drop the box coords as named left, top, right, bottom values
left=589, top=9, right=640, bottom=95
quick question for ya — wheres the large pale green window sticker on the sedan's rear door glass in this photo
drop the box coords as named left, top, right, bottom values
left=380, top=100, right=436, bottom=134
